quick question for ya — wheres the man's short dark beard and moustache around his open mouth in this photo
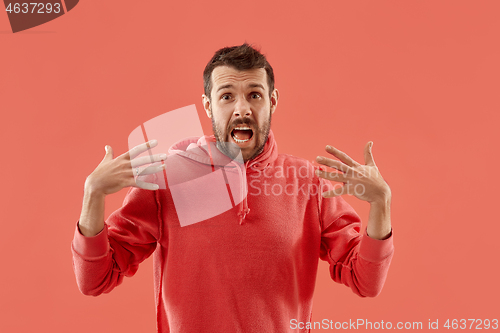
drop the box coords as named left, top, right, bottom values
left=212, top=112, right=272, bottom=162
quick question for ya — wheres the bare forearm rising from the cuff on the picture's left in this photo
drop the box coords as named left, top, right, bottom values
left=78, top=188, right=106, bottom=237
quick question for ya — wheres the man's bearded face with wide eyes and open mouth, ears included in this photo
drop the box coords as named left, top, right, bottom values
left=202, top=66, right=279, bottom=161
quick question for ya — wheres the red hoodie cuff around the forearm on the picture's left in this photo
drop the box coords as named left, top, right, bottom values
left=73, top=222, right=109, bottom=258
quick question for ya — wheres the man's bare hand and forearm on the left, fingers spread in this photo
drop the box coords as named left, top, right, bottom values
left=78, top=140, right=167, bottom=236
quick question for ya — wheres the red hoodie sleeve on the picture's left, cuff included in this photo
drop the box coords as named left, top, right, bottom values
left=71, top=188, right=160, bottom=296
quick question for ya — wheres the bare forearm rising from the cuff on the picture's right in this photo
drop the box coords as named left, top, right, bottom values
left=366, top=195, right=392, bottom=239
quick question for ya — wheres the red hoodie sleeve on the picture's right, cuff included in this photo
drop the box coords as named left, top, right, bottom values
left=319, top=179, right=394, bottom=297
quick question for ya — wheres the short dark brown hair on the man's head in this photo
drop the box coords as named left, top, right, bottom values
left=203, top=43, right=274, bottom=98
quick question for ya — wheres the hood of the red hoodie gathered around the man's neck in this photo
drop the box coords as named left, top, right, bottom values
left=168, top=130, right=278, bottom=224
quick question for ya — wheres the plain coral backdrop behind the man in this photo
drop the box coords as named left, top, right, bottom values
left=0, top=0, right=500, bottom=333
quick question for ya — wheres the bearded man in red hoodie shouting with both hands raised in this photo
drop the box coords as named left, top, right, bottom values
left=72, top=44, right=393, bottom=333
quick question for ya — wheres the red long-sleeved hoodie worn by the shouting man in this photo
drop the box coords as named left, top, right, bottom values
left=72, top=132, right=393, bottom=333
